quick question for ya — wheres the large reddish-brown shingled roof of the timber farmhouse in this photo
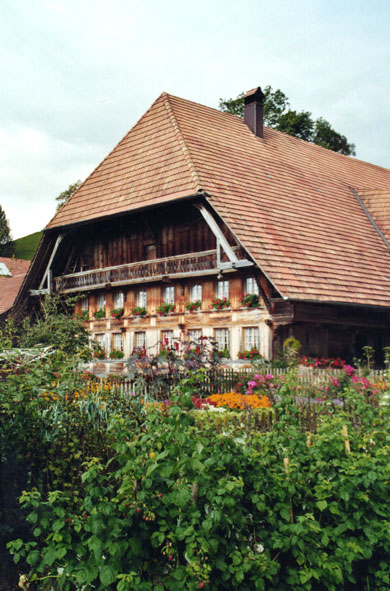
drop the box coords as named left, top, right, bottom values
left=47, top=93, right=390, bottom=306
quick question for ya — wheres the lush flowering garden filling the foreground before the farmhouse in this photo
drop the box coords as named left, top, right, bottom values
left=0, top=302, right=390, bottom=591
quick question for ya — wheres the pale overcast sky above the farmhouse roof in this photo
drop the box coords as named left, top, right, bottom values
left=0, top=0, right=390, bottom=238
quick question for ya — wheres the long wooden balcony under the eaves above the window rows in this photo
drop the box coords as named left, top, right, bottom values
left=54, top=247, right=253, bottom=293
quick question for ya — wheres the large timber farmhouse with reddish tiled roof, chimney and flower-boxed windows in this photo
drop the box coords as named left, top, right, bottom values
left=19, top=88, right=390, bottom=359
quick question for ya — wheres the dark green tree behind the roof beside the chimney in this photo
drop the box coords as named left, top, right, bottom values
left=219, top=85, right=356, bottom=156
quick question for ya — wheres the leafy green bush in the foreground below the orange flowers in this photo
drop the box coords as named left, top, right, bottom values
left=9, top=387, right=390, bottom=591
